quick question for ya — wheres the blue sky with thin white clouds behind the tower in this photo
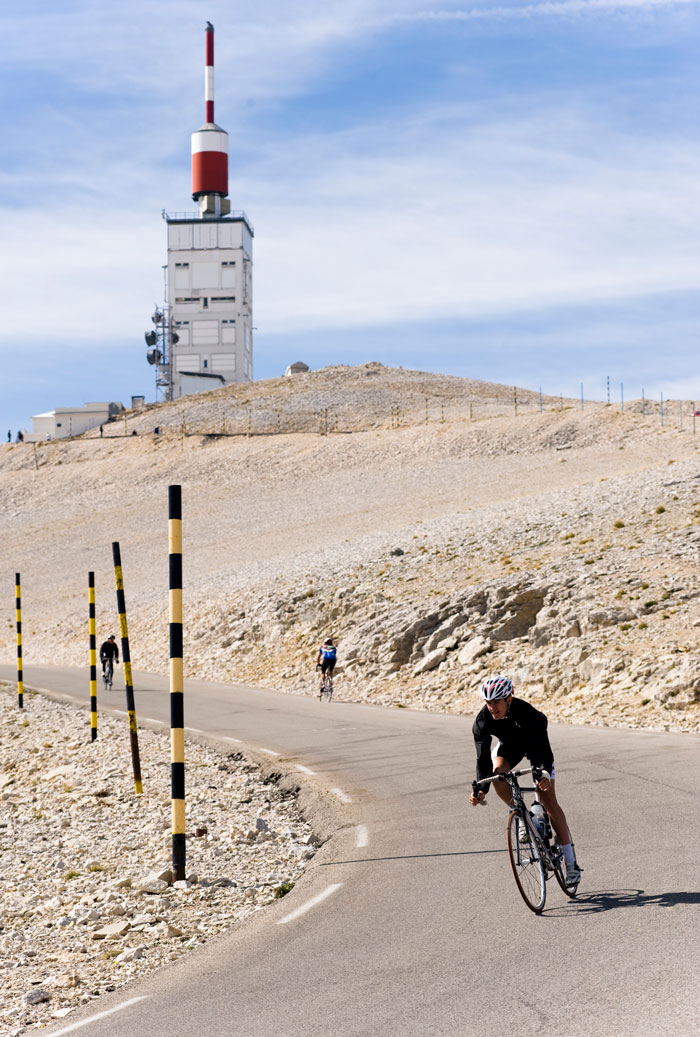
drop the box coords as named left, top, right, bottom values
left=0, top=0, right=700, bottom=429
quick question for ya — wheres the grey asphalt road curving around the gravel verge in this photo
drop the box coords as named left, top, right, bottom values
left=0, top=667, right=700, bottom=1037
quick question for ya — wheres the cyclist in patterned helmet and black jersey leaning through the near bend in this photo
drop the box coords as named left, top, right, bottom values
left=469, top=674, right=581, bottom=886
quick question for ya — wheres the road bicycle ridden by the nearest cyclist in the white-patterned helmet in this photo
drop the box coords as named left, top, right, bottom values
left=472, top=767, right=579, bottom=915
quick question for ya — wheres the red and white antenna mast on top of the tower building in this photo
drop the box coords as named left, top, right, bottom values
left=192, top=22, right=231, bottom=216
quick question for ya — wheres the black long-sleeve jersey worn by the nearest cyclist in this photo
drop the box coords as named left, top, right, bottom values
left=472, top=698, right=554, bottom=791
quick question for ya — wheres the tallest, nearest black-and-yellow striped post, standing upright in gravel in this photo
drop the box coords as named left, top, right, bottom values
left=168, top=486, right=187, bottom=882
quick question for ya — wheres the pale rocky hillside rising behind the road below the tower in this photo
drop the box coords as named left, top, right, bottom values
left=0, top=364, right=700, bottom=730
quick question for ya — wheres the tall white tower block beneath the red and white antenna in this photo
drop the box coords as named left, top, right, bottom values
left=165, top=213, right=253, bottom=399
